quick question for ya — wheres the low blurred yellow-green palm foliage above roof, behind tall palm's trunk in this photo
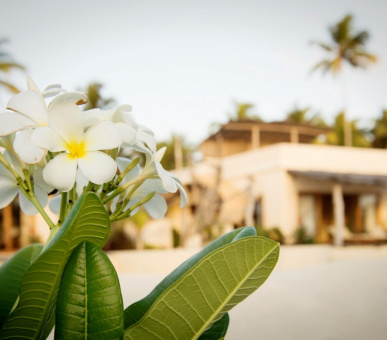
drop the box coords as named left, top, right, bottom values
left=324, top=112, right=371, bottom=148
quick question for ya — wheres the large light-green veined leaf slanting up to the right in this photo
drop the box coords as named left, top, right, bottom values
left=124, top=236, right=279, bottom=340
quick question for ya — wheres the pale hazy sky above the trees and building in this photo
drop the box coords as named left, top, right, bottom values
left=0, top=0, right=387, bottom=143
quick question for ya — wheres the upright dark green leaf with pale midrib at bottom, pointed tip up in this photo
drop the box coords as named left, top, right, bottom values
left=55, top=242, right=124, bottom=340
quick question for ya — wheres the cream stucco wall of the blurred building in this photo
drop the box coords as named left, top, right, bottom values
left=217, top=143, right=387, bottom=236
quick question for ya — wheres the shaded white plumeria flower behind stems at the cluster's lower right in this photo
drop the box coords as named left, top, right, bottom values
left=112, top=157, right=167, bottom=219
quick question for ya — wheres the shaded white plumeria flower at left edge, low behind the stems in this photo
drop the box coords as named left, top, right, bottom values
left=0, top=151, right=52, bottom=216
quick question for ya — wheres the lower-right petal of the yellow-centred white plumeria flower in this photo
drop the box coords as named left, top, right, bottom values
left=78, top=151, right=117, bottom=185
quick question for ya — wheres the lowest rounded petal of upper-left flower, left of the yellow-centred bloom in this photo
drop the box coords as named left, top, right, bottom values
left=13, top=129, right=46, bottom=164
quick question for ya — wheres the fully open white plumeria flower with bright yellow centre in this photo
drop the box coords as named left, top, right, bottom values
left=31, top=106, right=122, bottom=192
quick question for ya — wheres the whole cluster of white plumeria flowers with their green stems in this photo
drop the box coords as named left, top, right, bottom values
left=0, top=78, right=187, bottom=227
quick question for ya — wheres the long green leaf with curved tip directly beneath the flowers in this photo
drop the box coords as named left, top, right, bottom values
left=0, top=192, right=110, bottom=339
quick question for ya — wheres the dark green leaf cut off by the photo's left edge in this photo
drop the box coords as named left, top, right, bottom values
left=0, top=244, right=43, bottom=328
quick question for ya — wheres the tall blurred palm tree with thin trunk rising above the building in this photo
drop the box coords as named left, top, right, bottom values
left=312, top=15, right=376, bottom=146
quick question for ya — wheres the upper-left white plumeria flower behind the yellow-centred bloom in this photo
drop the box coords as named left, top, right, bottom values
left=0, top=78, right=87, bottom=164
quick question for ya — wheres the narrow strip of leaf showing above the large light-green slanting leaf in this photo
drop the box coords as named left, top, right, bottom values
left=124, top=227, right=257, bottom=328
